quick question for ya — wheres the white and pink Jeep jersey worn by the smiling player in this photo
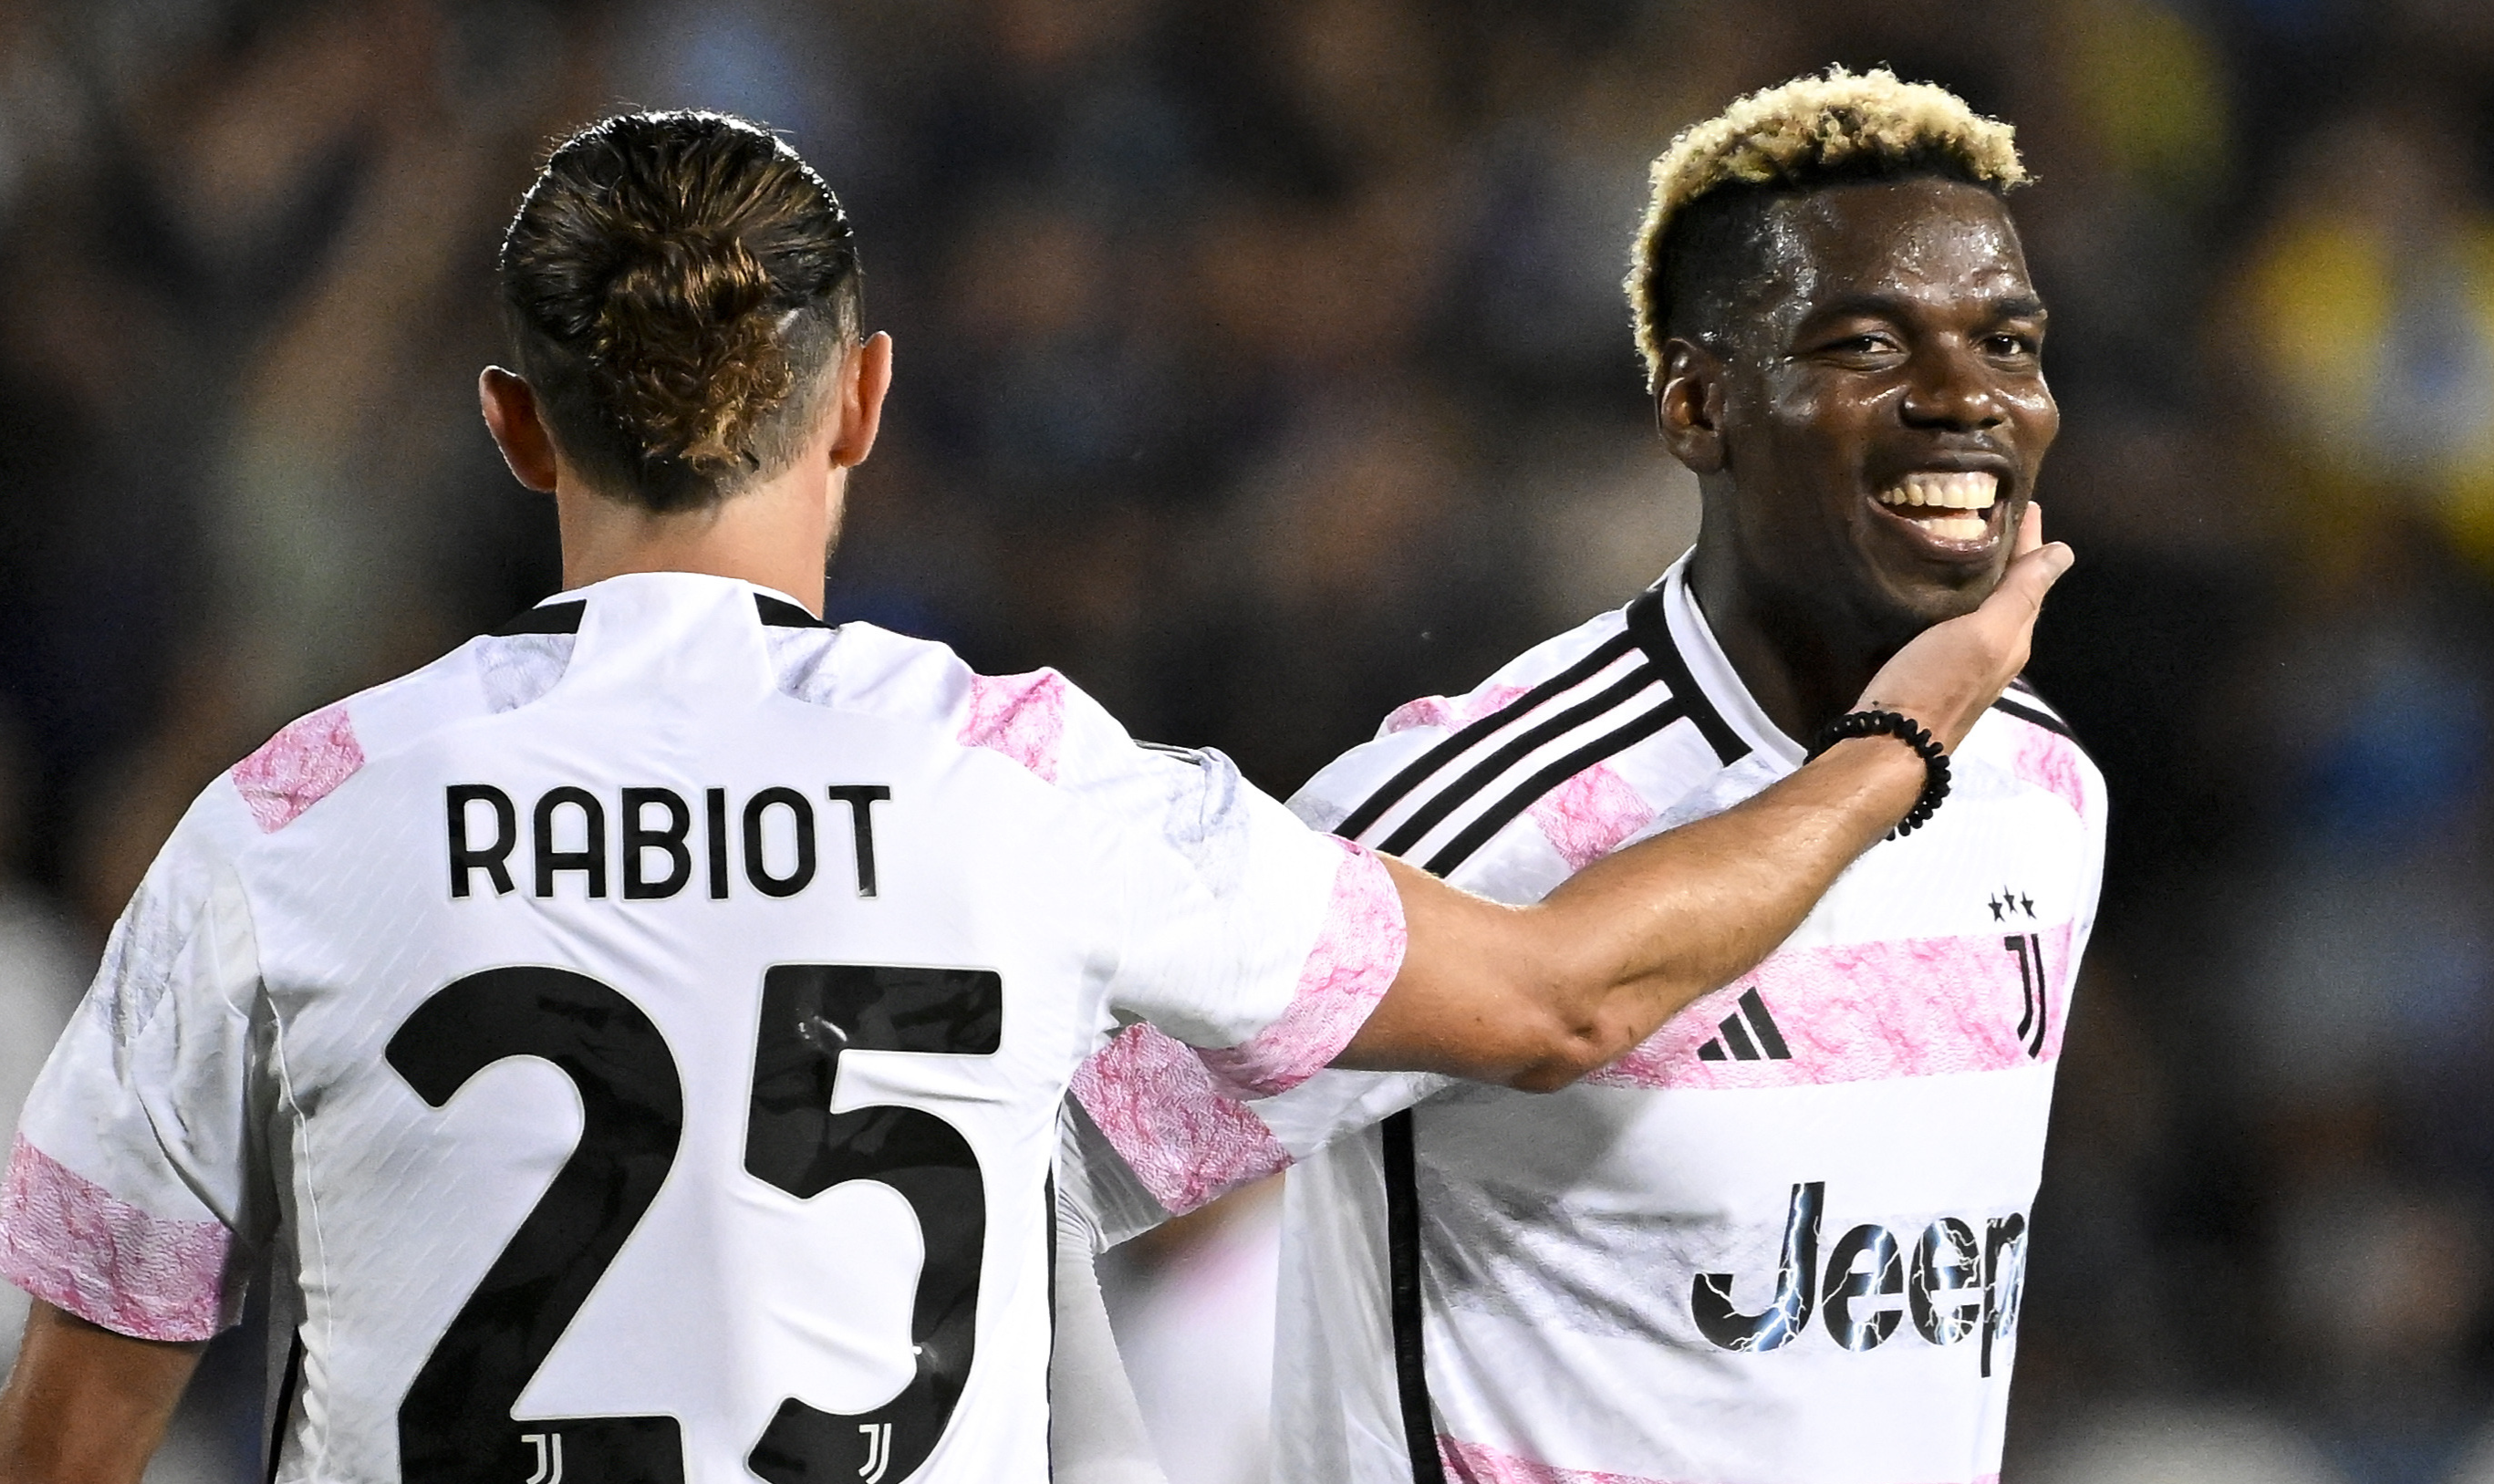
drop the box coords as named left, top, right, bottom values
left=1067, top=561, right=2104, bottom=1484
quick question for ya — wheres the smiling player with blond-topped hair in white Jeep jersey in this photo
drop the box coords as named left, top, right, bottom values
left=1060, top=70, right=2104, bottom=1484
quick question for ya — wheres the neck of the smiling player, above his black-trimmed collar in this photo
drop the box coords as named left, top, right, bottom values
left=1689, top=541, right=1898, bottom=746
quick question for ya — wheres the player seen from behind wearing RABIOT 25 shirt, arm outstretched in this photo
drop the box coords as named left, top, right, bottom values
left=0, top=112, right=2067, bottom=1484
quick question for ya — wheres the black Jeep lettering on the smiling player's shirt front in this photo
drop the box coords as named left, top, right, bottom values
left=1689, top=1179, right=2025, bottom=1376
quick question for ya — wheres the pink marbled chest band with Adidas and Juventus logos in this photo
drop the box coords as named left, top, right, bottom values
left=1586, top=918, right=2070, bottom=1087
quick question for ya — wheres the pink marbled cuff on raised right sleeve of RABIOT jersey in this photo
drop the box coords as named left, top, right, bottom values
left=1195, top=841, right=1407, bottom=1097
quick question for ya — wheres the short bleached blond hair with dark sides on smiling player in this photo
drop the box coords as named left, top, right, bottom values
left=1626, top=67, right=2028, bottom=389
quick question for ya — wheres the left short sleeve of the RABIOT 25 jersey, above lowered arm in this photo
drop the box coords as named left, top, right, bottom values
left=0, top=821, right=267, bottom=1339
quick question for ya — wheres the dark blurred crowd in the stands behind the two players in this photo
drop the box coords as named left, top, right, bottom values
left=0, top=0, right=2494, bottom=1484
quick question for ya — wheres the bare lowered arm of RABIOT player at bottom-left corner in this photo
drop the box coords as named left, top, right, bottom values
left=0, top=1300, right=207, bottom=1484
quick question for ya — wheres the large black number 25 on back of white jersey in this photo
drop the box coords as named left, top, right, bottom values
left=387, top=962, right=1005, bottom=1484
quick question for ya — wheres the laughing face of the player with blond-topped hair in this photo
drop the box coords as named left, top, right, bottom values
left=1706, top=180, right=2060, bottom=638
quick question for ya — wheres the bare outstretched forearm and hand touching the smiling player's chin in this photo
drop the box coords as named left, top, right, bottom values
left=1335, top=512, right=2070, bottom=1090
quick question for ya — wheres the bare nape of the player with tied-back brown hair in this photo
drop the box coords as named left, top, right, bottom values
left=554, top=459, right=848, bottom=616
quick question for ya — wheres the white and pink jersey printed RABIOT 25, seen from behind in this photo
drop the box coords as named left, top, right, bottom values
left=0, top=574, right=1402, bottom=1484
